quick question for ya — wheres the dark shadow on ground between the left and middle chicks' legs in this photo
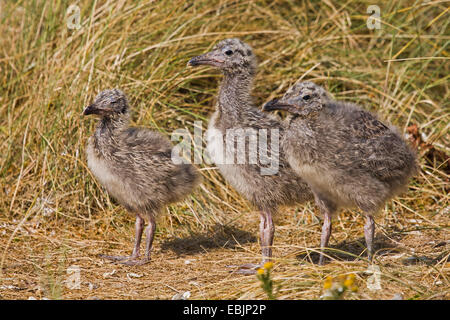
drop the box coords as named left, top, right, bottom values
left=161, top=225, right=257, bottom=255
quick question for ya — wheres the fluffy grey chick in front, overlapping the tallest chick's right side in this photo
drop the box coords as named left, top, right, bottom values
left=264, top=82, right=417, bottom=264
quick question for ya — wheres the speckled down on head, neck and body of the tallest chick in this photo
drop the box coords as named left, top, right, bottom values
left=188, top=39, right=313, bottom=209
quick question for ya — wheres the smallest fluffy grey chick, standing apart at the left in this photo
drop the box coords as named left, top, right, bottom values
left=83, top=89, right=200, bottom=265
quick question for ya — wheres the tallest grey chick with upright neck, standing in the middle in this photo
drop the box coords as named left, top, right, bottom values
left=188, top=39, right=313, bottom=273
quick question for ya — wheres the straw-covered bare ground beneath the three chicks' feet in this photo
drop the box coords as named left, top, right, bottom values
left=0, top=202, right=450, bottom=299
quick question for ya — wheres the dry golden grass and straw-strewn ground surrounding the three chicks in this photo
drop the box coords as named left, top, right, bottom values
left=0, top=0, right=450, bottom=299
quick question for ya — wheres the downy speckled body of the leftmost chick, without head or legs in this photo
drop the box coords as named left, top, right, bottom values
left=87, top=119, right=199, bottom=215
